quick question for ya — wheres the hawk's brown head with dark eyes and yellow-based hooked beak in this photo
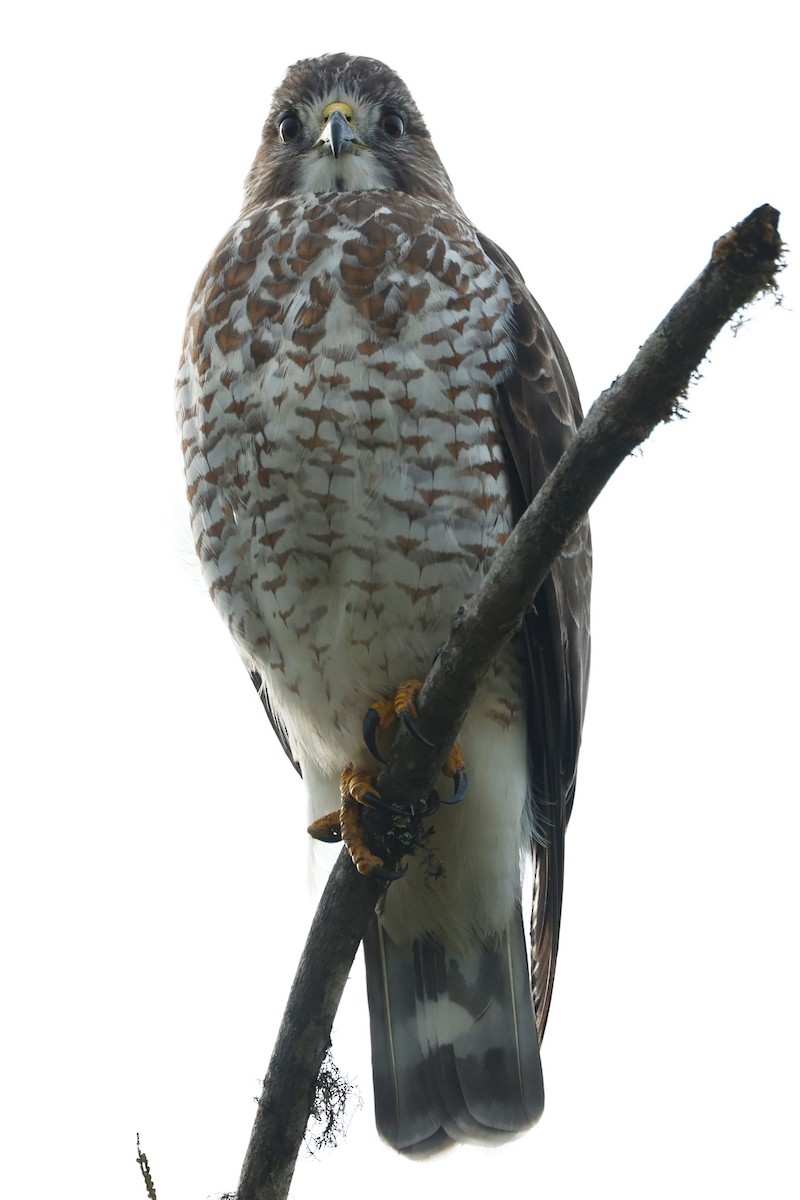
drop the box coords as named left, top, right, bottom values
left=245, top=54, right=453, bottom=210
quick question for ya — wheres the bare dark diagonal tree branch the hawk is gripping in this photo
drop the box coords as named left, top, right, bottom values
left=237, top=204, right=782, bottom=1200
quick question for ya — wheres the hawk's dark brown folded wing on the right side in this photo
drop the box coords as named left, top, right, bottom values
left=481, top=235, right=591, bottom=1040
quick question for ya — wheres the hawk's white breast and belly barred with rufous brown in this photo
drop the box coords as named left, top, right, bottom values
left=178, top=192, right=519, bottom=775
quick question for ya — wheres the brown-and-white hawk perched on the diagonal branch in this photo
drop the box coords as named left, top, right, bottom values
left=178, top=54, right=590, bottom=1152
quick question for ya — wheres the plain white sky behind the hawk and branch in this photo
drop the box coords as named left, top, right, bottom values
left=0, top=0, right=800, bottom=1200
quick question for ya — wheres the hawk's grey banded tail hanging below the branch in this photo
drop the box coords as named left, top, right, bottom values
left=363, top=912, right=545, bottom=1154
